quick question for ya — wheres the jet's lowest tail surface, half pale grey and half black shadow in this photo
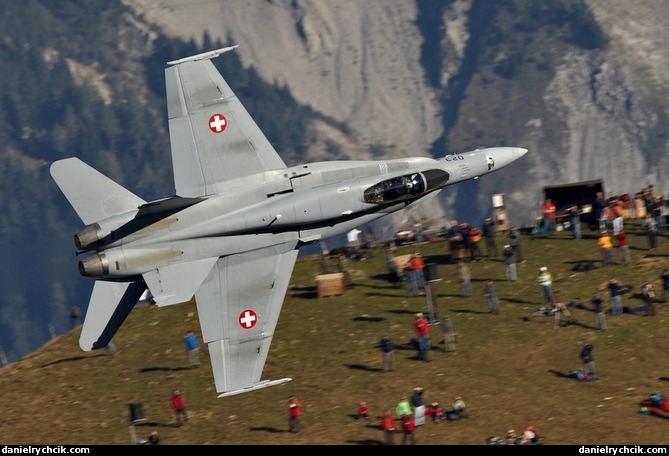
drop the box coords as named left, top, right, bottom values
left=79, top=280, right=146, bottom=351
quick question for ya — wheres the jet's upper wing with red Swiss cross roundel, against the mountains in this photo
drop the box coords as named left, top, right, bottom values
left=165, top=46, right=286, bottom=197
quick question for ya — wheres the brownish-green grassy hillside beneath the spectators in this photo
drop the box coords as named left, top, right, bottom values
left=0, top=222, right=669, bottom=445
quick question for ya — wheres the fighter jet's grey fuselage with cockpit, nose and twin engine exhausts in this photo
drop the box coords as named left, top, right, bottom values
left=76, top=151, right=526, bottom=279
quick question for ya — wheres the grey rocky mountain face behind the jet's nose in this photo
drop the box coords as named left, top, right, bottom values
left=124, top=0, right=669, bottom=225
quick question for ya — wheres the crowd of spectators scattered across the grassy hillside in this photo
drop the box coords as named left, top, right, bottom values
left=145, top=184, right=669, bottom=445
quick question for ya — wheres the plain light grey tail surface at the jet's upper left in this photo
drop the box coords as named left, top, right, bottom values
left=50, top=158, right=146, bottom=225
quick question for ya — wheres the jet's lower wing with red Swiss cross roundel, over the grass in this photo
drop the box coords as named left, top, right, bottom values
left=195, top=243, right=298, bottom=397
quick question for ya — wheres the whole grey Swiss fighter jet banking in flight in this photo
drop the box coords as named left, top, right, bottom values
left=50, top=46, right=527, bottom=397
